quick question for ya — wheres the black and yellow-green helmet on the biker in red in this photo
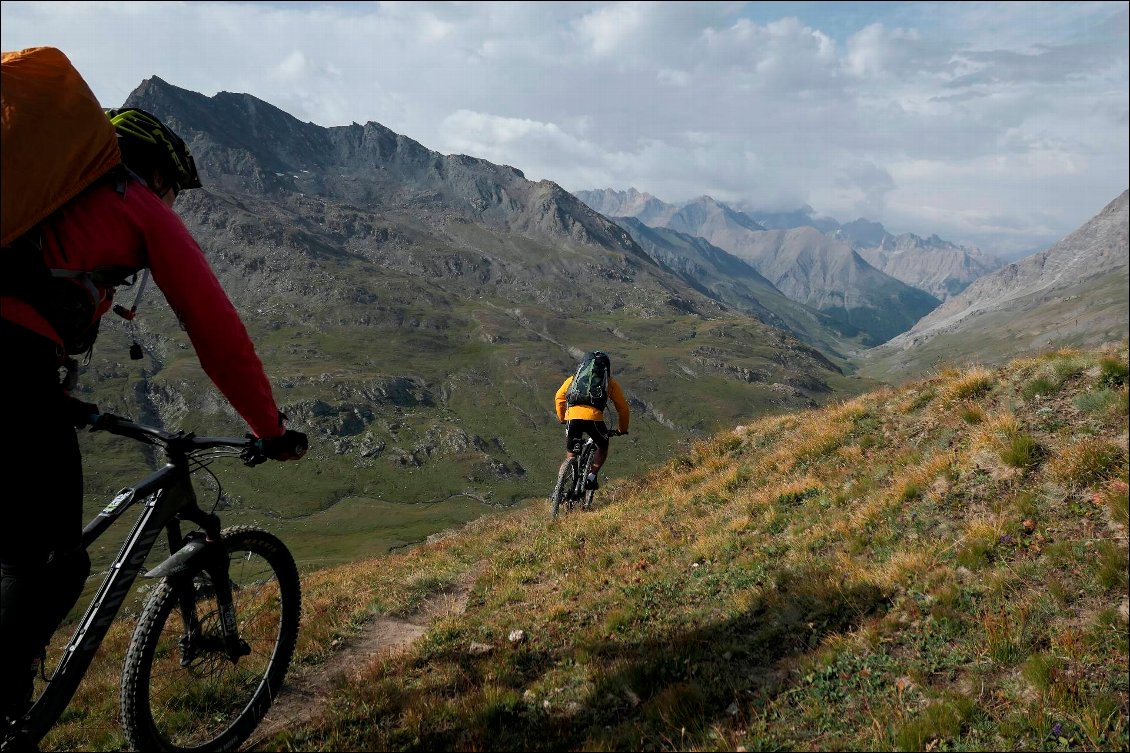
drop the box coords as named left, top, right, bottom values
left=106, top=107, right=203, bottom=192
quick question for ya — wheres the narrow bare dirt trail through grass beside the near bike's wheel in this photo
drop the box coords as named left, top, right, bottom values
left=242, top=568, right=480, bottom=751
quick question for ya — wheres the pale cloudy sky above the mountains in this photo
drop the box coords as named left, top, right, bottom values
left=0, top=1, right=1130, bottom=256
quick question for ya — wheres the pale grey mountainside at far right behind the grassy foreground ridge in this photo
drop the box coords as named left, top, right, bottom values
left=861, top=185, right=1130, bottom=379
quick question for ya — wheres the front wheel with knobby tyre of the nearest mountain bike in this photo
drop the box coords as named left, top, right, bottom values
left=122, top=526, right=302, bottom=751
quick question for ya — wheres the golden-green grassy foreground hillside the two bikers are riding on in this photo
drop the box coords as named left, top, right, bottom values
left=39, top=344, right=1128, bottom=750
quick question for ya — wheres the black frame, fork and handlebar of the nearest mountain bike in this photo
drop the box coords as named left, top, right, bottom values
left=18, top=432, right=246, bottom=743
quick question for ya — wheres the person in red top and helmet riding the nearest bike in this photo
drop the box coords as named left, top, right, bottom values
left=0, top=109, right=306, bottom=719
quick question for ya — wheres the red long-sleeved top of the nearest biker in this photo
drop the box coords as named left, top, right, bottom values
left=0, top=180, right=284, bottom=439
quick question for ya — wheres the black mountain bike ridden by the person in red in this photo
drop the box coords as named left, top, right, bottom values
left=2, top=414, right=302, bottom=751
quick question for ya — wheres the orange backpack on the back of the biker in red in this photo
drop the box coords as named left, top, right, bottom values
left=0, top=47, right=122, bottom=248
